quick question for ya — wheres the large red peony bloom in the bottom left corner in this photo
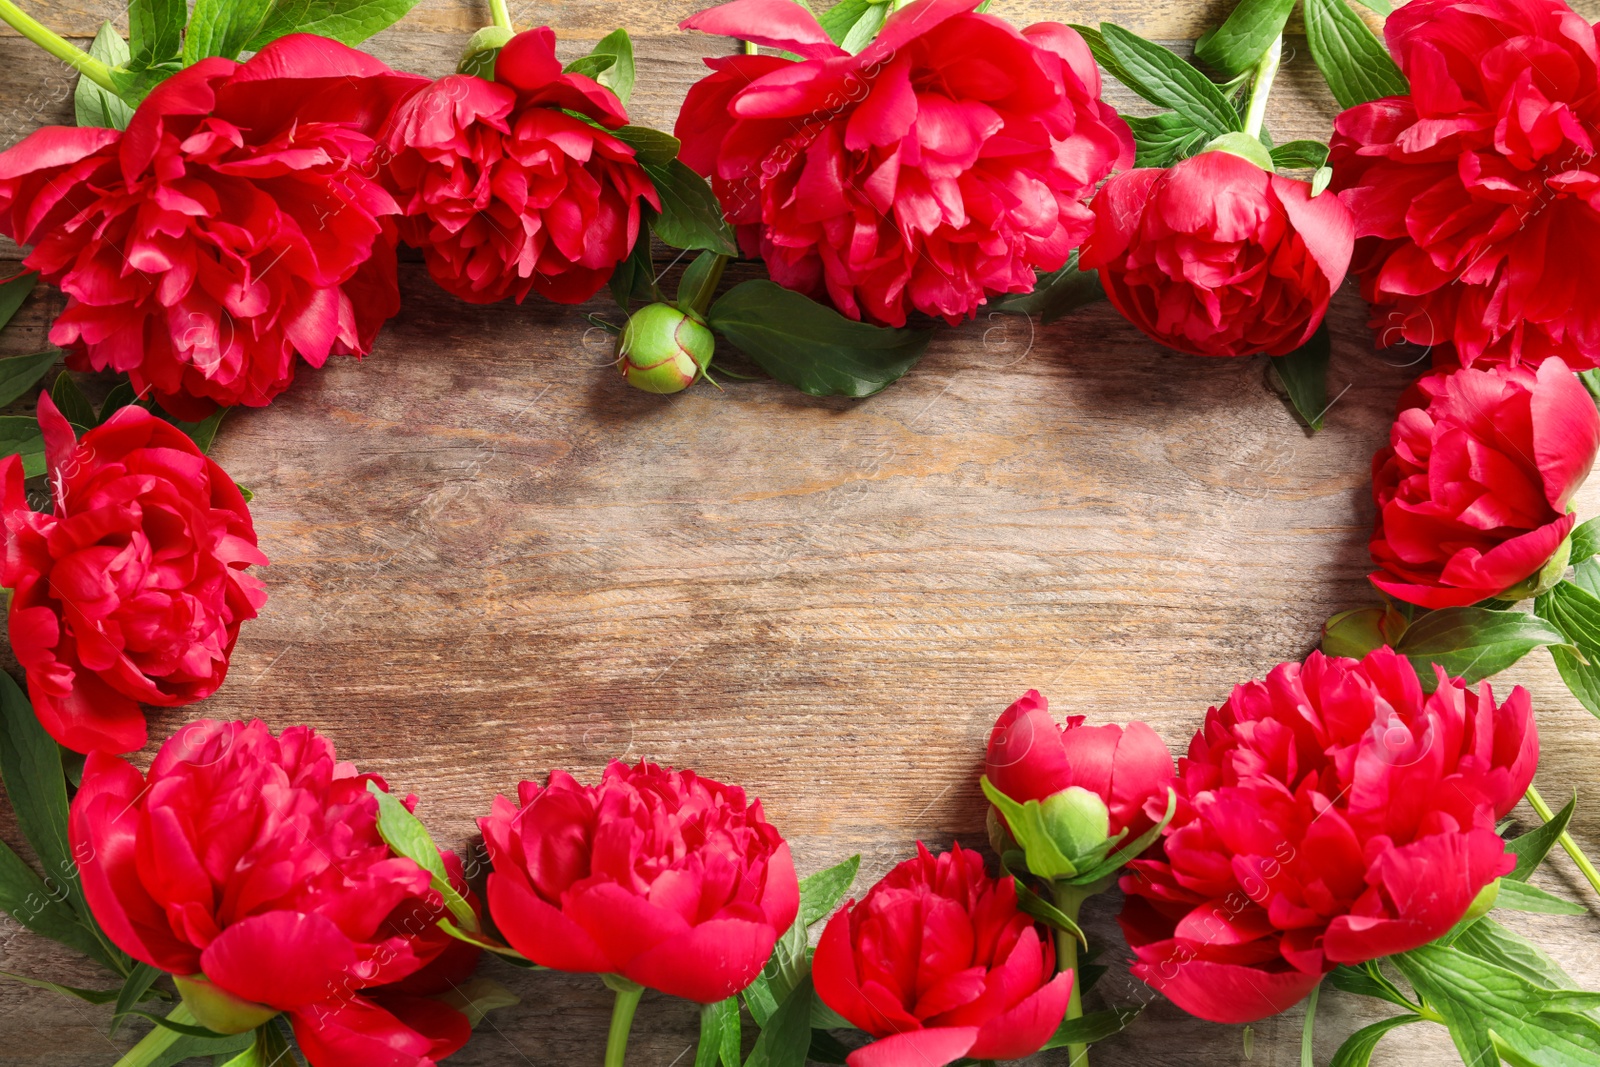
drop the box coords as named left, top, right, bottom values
left=70, top=720, right=470, bottom=1067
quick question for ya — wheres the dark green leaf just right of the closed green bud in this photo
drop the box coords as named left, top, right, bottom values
left=706, top=280, right=933, bottom=397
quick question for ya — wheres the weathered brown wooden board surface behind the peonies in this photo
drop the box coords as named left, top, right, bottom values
left=0, top=0, right=1600, bottom=1067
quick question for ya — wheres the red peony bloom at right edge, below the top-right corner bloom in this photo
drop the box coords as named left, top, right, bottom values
left=1371, top=357, right=1600, bottom=608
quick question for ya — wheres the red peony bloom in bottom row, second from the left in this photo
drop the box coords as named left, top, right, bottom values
left=478, top=761, right=800, bottom=1005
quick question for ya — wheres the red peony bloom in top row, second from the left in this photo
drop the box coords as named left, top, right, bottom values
left=384, top=27, right=661, bottom=304
